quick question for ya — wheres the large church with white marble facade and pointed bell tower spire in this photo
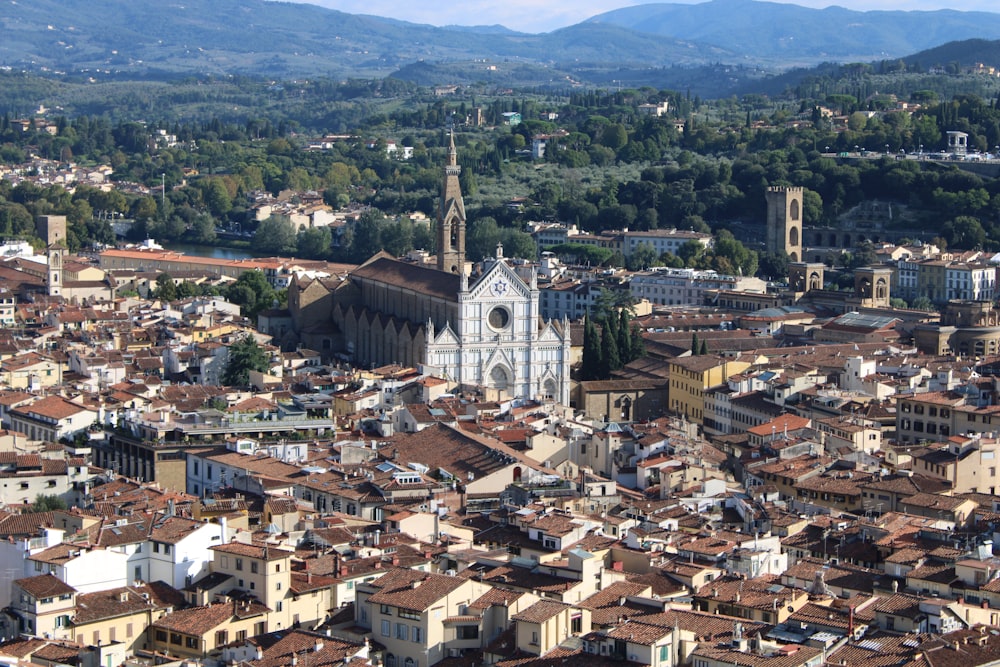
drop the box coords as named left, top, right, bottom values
left=286, top=136, right=570, bottom=405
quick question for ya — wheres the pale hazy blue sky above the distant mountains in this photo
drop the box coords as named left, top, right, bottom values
left=309, top=0, right=997, bottom=33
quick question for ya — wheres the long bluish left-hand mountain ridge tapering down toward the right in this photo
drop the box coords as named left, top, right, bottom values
left=0, top=0, right=738, bottom=79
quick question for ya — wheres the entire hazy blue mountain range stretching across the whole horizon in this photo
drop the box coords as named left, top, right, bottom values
left=0, top=0, right=1000, bottom=87
